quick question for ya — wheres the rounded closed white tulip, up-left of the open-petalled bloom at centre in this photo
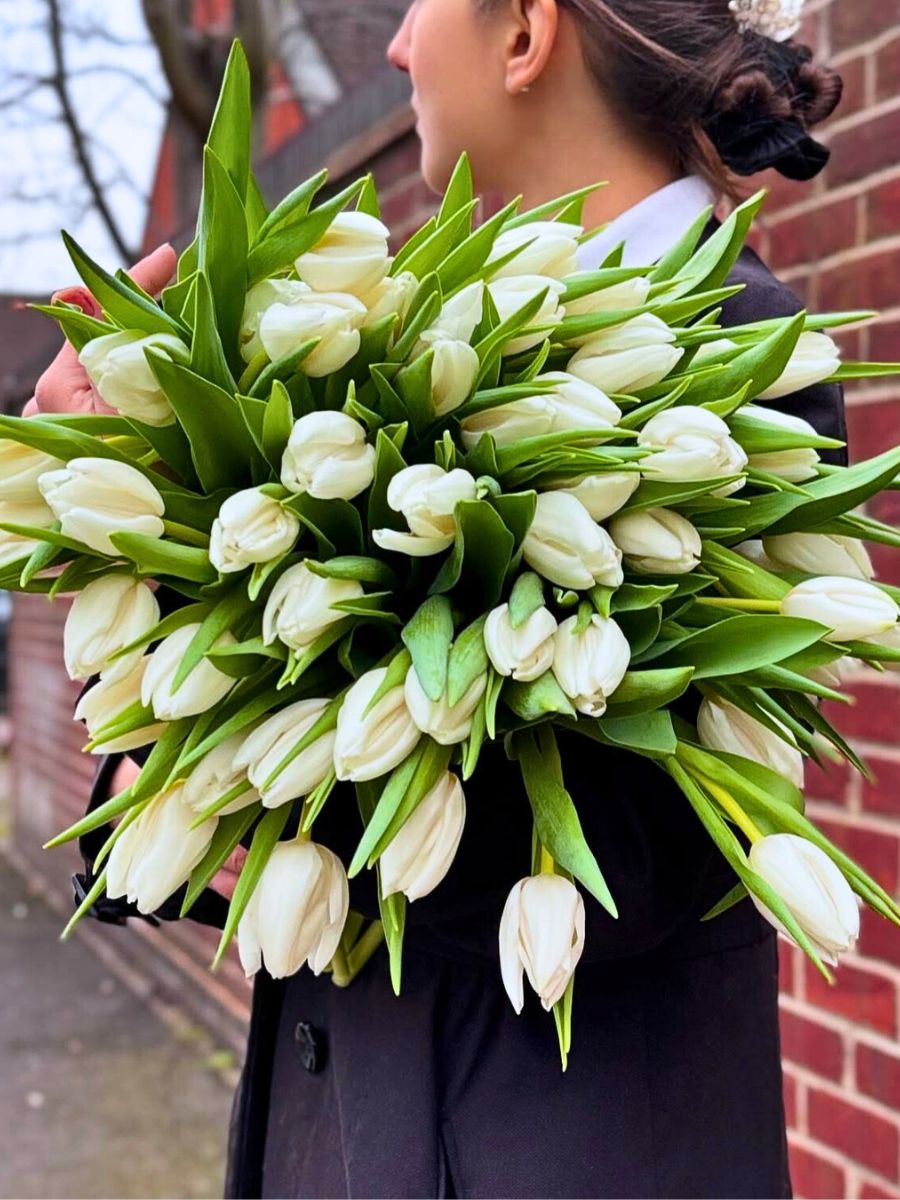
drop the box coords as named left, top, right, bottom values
left=281, top=412, right=374, bottom=500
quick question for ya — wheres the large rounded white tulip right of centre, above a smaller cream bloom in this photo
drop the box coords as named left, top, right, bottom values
left=637, top=404, right=748, bottom=496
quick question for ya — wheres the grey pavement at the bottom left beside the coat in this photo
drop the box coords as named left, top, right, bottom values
left=0, top=857, right=232, bottom=1200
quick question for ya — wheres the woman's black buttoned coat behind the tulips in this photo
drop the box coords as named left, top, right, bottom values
left=81, top=229, right=845, bottom=1198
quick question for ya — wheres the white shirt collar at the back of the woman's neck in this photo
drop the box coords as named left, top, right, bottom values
left=578, top=175, right=715, bottom=271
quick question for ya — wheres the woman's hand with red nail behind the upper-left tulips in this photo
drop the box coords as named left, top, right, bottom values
left=22, top=244, right=178, bottom=416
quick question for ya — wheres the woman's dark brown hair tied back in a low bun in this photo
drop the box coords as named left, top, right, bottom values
left=475, top=0, right=842, bottom=193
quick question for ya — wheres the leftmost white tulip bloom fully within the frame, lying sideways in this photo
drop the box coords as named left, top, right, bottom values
left=37, top=458, right=166, bottom=557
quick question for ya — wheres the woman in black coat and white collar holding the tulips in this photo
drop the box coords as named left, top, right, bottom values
left=31, top=0, right=844, bottom=1196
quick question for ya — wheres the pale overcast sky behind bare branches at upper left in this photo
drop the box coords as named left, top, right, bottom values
left=0, top=0, right=166, bottom=295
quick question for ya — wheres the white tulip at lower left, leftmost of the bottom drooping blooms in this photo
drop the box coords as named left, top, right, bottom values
left=107, top=784, right=218, bottom=913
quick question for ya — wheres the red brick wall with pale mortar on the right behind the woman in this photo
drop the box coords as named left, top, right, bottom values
left=761, top=0, right=900, bottom=1198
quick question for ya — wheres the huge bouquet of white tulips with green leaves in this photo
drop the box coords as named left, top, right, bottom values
left=10, top=47, right=900, bottom=1060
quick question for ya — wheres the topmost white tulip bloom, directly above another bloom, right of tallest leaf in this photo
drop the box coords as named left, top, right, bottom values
left=294, top=212, right=390, bottom=296
